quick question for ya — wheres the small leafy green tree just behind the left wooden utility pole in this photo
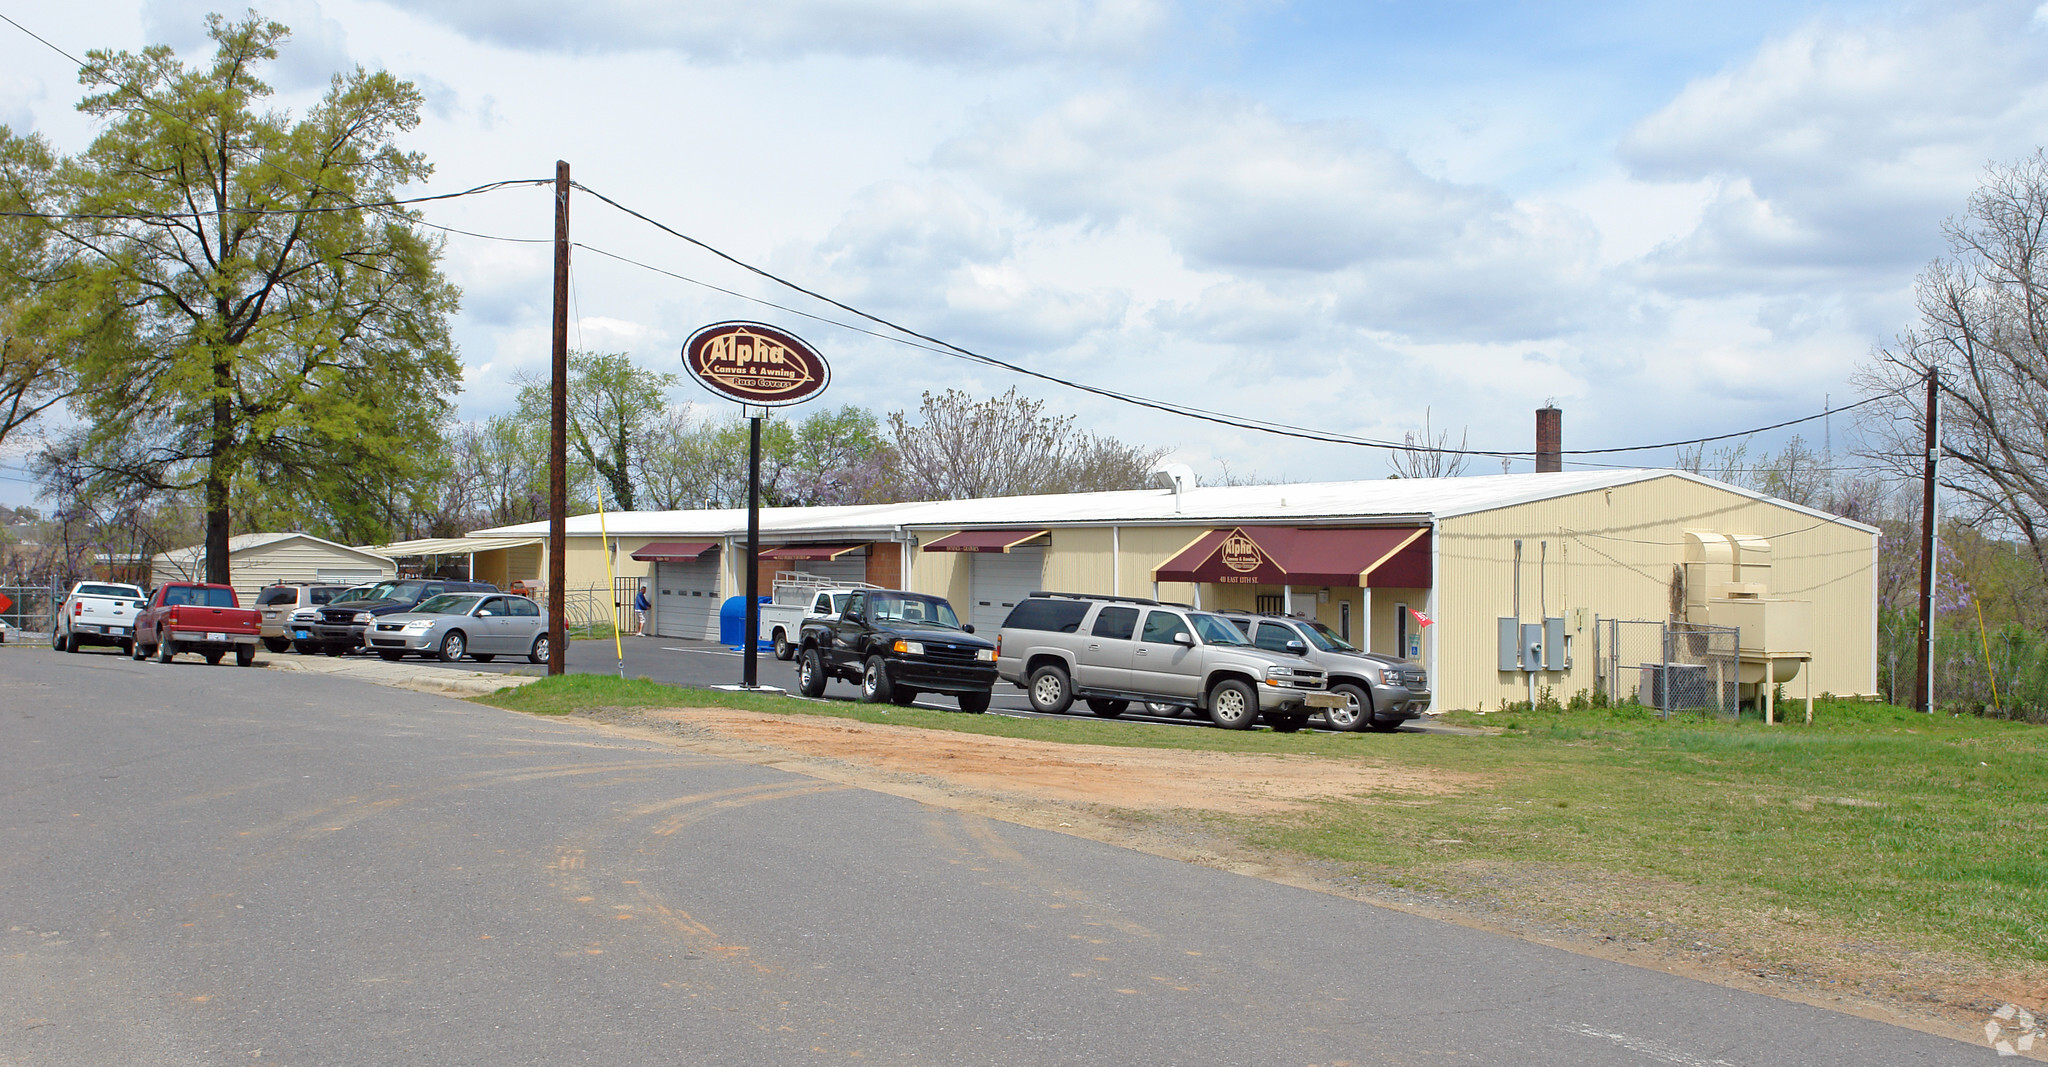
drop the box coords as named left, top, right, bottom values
left=518, top=352, right=682, bottom=512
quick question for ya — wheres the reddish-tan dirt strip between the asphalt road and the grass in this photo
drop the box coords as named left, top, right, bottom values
left=580, top=709, right=2048, bottom=1061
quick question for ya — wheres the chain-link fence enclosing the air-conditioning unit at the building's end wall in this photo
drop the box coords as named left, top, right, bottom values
left=1593, top=618, right=1743, bottom=719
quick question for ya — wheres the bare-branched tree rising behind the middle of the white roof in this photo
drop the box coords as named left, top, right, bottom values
left=889, top=387, right=1165, bottom=500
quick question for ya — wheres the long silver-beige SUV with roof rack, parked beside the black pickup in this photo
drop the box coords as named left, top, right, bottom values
left=995, top=592, right=1341, bottom=731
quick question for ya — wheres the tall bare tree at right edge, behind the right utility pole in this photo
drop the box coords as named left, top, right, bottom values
left=1858, top=152, right=2048, bottom=567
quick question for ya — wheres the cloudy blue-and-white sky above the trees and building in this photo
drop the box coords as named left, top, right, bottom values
left=0, top=0, right=2048, bottom=496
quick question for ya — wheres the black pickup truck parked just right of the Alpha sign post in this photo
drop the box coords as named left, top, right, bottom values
left=797, top=590, right=995, bottom=713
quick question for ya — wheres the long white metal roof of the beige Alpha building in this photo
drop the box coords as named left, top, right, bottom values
left=473, top=469, right=1876, bottom=539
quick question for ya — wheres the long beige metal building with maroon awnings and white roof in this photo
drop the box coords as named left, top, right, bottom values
left=477, top=469, right=1878, bottom=709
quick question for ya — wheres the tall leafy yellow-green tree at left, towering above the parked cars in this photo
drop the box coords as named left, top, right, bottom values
left=39, top=12, right=459, bottom=582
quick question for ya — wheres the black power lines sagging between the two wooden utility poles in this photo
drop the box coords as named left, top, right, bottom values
left=569, top=182, right=1892, bottom=459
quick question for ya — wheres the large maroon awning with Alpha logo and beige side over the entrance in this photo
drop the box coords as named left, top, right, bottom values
left=1153, top=526, right=1430, bottom=590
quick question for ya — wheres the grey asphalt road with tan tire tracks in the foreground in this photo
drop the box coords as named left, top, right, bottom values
left=0, top=647, right=1993, bottom=1067
